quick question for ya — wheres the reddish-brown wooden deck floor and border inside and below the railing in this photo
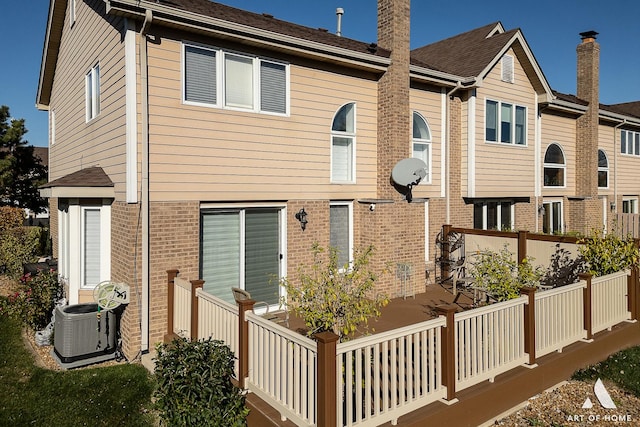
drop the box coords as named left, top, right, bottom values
left=248, top=284, right=640, bottom=426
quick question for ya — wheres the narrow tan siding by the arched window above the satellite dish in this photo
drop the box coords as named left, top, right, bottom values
left=407, top=88, right=444, bottom=201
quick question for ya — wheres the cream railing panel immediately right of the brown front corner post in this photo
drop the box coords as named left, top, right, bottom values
left=336, top=317, right=446, bottom=426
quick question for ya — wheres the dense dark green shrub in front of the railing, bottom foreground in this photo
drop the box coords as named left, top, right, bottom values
left=154, top=338, right=249, bottom=426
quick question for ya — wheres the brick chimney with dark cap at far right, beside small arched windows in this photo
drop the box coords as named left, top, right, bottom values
left=570, top=31, right=602, bottom=234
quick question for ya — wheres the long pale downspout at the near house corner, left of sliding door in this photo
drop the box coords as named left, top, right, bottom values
left=139, top=9, right=153, bottom=353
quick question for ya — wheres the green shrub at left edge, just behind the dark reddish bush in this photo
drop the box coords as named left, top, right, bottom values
left=0, top=227, right=45, bottom=278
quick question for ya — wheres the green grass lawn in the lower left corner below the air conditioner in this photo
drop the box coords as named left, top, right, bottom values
left=0, top=316, right=154, bottom=427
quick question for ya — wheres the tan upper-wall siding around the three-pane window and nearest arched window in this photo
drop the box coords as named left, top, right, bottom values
left=149, top=38, right=377, bottom=201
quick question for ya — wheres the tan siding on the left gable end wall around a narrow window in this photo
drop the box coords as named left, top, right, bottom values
left=49, top=0, right=126, bottom=198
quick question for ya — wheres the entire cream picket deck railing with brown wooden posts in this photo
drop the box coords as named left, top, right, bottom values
left=168, top=268, right=640, bottom=426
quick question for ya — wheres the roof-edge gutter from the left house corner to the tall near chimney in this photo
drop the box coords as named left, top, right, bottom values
left=105, top=0, right=391, bottom=72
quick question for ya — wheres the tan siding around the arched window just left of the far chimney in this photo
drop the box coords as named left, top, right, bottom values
left=540, top=113, right=576, bottom=197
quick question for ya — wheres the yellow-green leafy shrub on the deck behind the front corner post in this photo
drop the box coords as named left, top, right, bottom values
left=280, top=243, right=389, bottom=340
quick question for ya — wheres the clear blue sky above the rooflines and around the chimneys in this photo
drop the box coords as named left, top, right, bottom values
left=0, top=0, right=640, bottom=146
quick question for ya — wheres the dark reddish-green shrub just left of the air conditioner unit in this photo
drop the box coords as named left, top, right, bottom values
left=0, top=270, right=62, bottom=330
